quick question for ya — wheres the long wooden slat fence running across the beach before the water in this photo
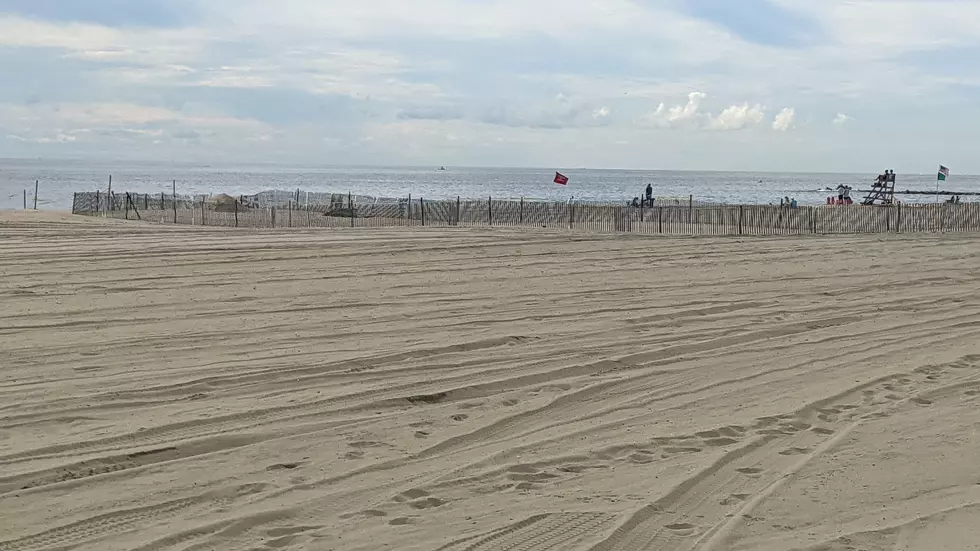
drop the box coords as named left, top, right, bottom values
left=72, top=192, right=980, bottom=236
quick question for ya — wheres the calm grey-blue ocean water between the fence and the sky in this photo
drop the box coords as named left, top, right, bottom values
left=0, top=160, right=980, bottom=210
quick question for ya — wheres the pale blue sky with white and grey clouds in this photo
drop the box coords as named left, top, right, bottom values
left=0, top=0, right=980, bottom=174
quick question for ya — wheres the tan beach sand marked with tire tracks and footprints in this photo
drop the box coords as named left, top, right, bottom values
left=0, top=213, right=980, bottom=551
